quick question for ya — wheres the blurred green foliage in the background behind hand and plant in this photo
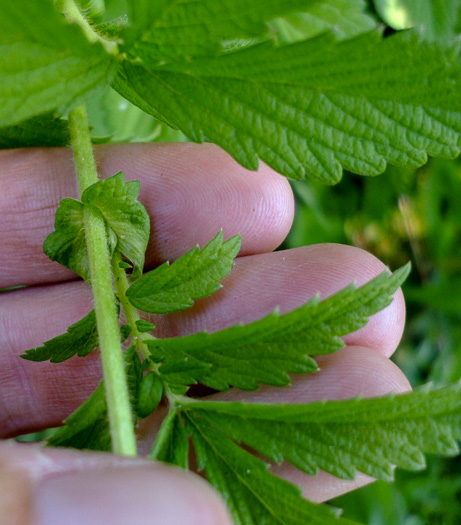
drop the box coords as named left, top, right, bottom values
left=16, top=0, right=461, bottom=525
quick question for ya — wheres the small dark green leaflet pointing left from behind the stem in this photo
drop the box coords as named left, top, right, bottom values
left=20, top=310, right=99, bottom=363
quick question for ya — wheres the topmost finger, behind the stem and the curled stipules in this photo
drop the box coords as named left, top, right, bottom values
left=0, top=144, right=294, bottom=288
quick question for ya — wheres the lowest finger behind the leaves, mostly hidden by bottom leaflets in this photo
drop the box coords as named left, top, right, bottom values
left=138, top=346, right=411, bottom=503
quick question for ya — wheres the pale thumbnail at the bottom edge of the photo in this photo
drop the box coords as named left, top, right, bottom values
left=34, top=465, right=232, bottom=525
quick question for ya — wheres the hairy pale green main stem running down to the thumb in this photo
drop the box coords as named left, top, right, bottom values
left=69, top=105, right=136, bottom=456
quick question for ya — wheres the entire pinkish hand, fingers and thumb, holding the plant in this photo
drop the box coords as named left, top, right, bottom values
left=0, top=144, right=410, bottom=525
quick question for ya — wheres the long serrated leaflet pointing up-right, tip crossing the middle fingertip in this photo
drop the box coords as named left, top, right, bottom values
left=145, top=265, right=410, bottom=390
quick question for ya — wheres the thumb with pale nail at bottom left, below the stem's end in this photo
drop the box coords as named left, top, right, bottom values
left=0, top=443, right=232, bottom=525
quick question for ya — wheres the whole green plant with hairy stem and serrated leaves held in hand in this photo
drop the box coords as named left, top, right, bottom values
left=0, top=0, right=461, bottom=525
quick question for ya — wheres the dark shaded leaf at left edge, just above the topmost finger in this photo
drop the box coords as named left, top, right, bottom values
left=0, top=113, right=70, bottom=149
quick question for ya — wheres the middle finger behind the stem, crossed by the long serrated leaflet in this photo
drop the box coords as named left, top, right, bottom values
left=0, top=245, right=405, bottom=437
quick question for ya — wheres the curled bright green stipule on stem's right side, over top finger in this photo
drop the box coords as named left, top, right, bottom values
left=82, top=172, right=150, bottom=276
